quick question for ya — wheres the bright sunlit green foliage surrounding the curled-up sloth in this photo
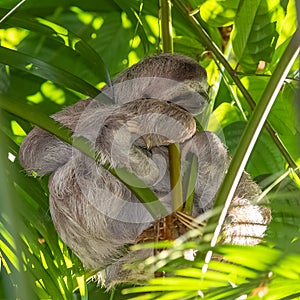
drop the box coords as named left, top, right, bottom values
left=0, top=0, right=300, bottom=299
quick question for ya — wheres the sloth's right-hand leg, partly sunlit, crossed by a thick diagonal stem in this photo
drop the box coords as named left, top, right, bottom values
left=183, top=132, right=271, bottom=245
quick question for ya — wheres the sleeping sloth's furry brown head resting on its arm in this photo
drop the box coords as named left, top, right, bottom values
left=103, top=54, right=208, bottom=115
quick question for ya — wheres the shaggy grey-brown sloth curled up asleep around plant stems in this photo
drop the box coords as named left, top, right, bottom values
left=19, top=54, right=270, bottom=285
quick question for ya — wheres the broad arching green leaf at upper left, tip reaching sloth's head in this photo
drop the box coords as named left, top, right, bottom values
left=0, top=10, right=109, bottom=83
